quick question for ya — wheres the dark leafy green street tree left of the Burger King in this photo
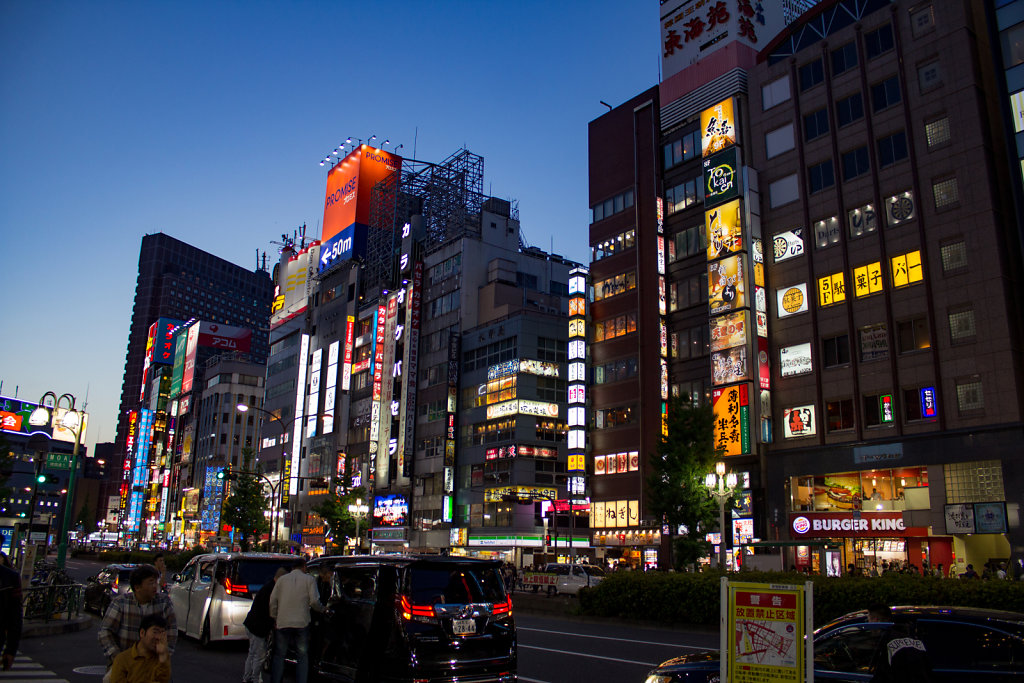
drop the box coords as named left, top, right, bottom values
left=647, top=398, right=719, bottom=568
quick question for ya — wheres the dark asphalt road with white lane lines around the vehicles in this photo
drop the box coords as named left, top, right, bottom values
left=16, top=559, right=718, bottom=683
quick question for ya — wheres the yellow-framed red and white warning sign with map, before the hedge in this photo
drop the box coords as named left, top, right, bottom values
left=720, top=577, right=814, bottom=683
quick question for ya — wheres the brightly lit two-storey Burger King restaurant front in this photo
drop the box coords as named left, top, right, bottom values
left=790, top=467, right=952, bottom=575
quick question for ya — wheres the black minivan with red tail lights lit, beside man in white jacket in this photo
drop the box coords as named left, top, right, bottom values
left=309, top=555, right=517, bottom=683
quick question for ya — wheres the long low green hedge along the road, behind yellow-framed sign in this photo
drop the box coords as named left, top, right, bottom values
left=579, top=571, right=1024, bottom=626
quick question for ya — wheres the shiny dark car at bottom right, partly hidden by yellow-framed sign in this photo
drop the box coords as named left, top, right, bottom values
left=646, top=607, right=1024, bottom=683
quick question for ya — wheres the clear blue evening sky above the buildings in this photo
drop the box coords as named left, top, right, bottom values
left=0, top=0, right=658, bottom=456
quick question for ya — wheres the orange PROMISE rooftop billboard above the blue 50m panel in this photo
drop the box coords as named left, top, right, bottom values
left=321, top=144, right=401, bottom=243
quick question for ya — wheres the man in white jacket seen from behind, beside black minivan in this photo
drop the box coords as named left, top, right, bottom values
left=270, top=560, right=324, bottom=683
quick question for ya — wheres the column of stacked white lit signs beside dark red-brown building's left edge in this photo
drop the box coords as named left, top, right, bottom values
left=566, top=268, right=588, bottom=496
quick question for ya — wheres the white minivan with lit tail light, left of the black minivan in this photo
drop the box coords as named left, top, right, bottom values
left=167, top=553, right=299, bottom=646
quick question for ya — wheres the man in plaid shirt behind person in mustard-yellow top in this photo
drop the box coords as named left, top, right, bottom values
left=96, top=564, right=178, bottom=668
